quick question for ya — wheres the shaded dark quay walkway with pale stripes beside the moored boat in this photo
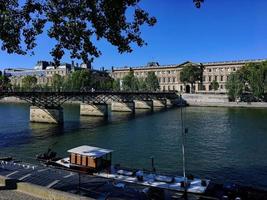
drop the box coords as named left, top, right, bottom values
left=0, top=161, right=147, bottom=199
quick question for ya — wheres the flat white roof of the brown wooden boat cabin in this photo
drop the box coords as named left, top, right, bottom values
left=68, top=145, right=113, bottom=158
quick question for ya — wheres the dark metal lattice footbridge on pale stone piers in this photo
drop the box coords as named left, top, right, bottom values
left=0, top=91, right=182, bottom=123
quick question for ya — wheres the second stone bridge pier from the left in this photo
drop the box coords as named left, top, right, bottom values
left=80, top=103, right=108, bottom=117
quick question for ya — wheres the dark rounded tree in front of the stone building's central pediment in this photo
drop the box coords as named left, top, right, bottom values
left=180, top=64, right=203, bottom=93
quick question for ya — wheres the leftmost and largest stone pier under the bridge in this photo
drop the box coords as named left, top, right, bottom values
left=30, top=106, right=63, bottom=124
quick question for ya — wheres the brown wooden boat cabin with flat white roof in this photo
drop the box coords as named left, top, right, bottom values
left=68, top=145, right=113, bottom=171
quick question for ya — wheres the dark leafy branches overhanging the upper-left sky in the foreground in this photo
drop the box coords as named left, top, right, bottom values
left=0, top=0, right=156, bottom=65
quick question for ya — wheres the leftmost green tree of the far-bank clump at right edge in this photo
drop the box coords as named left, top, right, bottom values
left=226, top=71, right=245, bottom=100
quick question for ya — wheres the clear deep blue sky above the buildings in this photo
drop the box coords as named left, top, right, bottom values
left=0, top=0, right=267, bottom=69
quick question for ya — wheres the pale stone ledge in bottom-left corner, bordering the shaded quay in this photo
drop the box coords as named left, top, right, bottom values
left=0, top=176, right=92, bottom=200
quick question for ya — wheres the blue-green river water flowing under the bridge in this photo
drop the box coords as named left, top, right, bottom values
left=0, top=104, right=267, bottom=189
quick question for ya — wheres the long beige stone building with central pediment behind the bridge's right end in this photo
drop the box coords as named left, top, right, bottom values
left=111, top=59, right=266, bottom=93
